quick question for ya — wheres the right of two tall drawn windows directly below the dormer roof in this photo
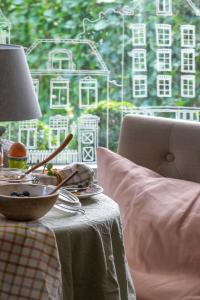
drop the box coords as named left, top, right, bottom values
left=79, top=77, right=98, bottom=108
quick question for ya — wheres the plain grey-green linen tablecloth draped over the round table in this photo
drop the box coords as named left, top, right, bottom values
left=41, top=194, right=136, bottom=300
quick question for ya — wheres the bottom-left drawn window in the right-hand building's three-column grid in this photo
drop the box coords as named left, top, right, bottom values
left=133, top=75, right=147, bottom=98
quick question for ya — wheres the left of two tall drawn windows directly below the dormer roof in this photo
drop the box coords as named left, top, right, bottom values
left=50, top=79, right=69, bottom=108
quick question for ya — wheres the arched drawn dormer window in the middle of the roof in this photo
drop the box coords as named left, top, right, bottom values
left=49, top=49, right=74, bottom=70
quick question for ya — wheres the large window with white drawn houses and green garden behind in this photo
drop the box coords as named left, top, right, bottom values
left=0, top=0, right=200, bottom=164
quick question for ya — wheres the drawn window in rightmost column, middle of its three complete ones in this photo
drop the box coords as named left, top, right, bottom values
left=181, top=49, right=195, bottom=73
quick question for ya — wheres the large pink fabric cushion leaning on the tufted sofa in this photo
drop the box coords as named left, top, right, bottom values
left=97, top=148, right=200, bottom=300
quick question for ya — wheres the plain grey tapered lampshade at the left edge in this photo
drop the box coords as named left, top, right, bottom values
left=0, top=44, right=41, bottom=121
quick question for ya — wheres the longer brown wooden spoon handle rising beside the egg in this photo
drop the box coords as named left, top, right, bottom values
left=17, top=133, right=73, bottom=180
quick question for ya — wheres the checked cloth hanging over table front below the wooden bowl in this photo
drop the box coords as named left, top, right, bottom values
left=0, top=218, right=62, bottom=300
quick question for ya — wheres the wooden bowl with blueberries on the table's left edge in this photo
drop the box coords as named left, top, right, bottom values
left=0, top=183, right=59, bottom=221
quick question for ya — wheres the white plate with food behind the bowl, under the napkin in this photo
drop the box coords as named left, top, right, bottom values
left=61, top=183, right=103, bottom=199
